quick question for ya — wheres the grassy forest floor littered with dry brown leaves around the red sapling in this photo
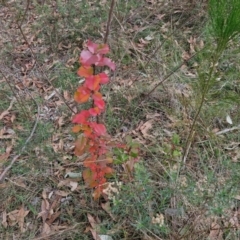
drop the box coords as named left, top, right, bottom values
left=0, top=0, right=240, bottom=240
